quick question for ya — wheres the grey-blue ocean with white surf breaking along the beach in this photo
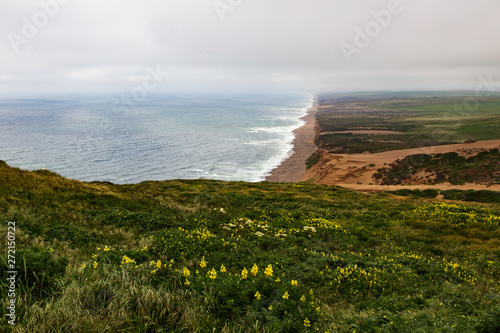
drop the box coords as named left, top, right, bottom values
left=0, top=93, right=313, bottom=184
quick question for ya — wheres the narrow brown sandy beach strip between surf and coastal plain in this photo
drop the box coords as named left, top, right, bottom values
left=265, top=95, right=318, bottom=183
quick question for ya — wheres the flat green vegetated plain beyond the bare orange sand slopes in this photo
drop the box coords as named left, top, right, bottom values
left=316, top=92, right=500, bottom=154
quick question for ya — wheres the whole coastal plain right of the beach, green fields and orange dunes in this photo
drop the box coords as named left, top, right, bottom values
left=273, top=92, right=500, bottom=191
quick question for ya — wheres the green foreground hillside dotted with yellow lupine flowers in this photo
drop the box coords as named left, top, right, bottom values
left=0, top=160, right=500, bottom=332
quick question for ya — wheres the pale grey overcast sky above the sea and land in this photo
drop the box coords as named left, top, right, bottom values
left=0, top=0, right=500, bottom=97
